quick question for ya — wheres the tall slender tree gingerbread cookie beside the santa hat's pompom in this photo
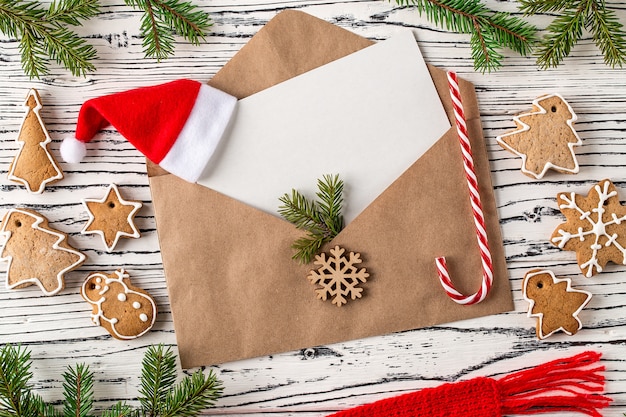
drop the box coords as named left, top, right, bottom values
left=8, top=89, right=63, bottom=194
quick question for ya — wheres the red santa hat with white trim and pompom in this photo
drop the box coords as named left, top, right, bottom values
left=61, top=80, right=237, bottom=182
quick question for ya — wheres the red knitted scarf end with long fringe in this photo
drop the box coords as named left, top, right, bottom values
left=328, top=352, right=611, bottom=417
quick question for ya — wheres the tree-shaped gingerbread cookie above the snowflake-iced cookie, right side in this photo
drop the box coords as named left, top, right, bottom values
left=496, top=94, right=582, bottom=179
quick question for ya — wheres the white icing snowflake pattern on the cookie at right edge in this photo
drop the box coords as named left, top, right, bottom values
left=552, top=181, right=626, bottom=278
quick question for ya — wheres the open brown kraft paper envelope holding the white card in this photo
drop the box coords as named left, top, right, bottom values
left=148, top=11, right=513, bottom=368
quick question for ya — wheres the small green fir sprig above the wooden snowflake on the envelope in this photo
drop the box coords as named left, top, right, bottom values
left=278, top=175, right=343, bottom=263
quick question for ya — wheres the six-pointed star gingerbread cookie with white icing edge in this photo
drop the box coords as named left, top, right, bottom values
left=81, top=184, right=142, bottom=252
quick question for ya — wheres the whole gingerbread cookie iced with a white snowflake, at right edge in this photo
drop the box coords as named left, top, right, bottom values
left=550, top=180, right=626, bottom=278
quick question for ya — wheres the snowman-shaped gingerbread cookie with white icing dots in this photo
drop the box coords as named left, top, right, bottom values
left=80, top=269, right=157, bottom=340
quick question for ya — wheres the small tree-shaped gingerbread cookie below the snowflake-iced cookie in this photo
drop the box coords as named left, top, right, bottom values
left=522, top=269, right=591, bottom=339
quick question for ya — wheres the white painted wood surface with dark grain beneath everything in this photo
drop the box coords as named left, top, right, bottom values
left=0, top=0, right=626, bottom=417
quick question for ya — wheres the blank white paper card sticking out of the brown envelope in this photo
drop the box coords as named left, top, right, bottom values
left=198, top=31, right=450, bottom=224
